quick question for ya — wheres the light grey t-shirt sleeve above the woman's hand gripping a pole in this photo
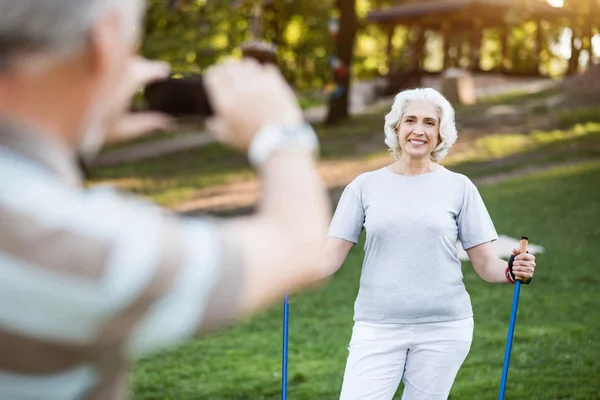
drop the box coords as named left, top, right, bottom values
left=457, top=178, right=498, bottom=250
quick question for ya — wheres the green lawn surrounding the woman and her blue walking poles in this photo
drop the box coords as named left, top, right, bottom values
left=132, top=161, right=600, bottom=400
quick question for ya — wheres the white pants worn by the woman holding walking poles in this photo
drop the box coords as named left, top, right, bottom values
left=340, top=318, right=473, bottom=400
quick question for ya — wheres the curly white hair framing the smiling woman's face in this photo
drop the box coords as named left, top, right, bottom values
left=384, top=88, right=458, bottom=161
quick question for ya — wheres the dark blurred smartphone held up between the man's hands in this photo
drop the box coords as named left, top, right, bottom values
left=144, top=75, right=213, bottom=119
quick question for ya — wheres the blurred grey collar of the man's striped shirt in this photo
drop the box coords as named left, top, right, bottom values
left=0, top=120, right=84, bottom=186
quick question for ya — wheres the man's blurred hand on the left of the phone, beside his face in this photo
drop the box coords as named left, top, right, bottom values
left=106, top=56, right=172, bottom=143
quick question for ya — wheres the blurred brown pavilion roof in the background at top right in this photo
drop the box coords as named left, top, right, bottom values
left=367, top=0, right=570, bottom=25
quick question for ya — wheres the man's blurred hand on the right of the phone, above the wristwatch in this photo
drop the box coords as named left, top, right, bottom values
left=204, top=59, right=303, bottom=150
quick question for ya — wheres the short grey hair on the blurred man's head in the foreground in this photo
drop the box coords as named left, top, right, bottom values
left=0, top=0, right=144, bottom=72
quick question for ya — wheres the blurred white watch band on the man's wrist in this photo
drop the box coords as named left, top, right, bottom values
left=248, top=123, right=319, bottom=167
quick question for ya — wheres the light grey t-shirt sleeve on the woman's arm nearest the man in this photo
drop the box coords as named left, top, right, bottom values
left=327, top=182, right=365, bottom=243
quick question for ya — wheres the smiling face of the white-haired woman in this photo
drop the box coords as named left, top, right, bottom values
left=396, top=101, right=441, bottom=159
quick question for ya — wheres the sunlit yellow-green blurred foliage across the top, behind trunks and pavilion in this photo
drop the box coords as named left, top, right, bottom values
left=141, top=0, right=588, bottom=90
